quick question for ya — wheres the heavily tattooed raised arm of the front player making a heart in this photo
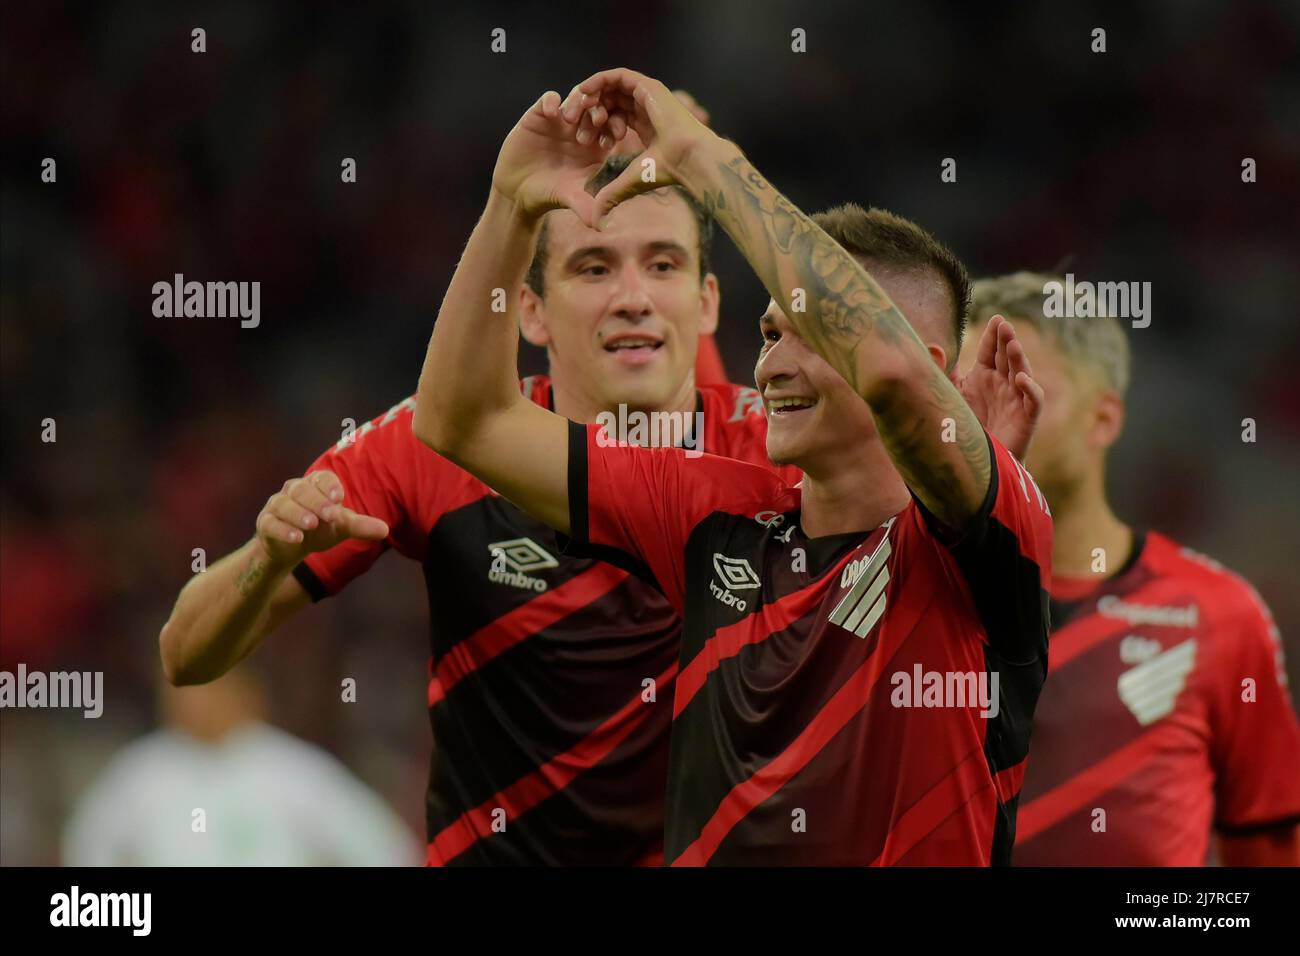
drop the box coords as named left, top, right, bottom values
left=579, top=70, right=992, bottom=529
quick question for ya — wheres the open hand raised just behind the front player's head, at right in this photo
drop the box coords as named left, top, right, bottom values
left=958, top=315, right=1043, bottom=462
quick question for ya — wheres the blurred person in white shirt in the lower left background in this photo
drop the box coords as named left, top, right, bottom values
left=62, top=665, right=420, bottom=866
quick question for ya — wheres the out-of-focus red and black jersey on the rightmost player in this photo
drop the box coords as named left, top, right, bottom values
left=1014, top=532, right=1300, bottom=866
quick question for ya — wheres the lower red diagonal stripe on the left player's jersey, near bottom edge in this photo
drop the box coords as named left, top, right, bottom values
left=425, top=663, right=677, bottom=866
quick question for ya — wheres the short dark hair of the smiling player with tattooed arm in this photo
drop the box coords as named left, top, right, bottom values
left=813, top=203, right=971, bottom=371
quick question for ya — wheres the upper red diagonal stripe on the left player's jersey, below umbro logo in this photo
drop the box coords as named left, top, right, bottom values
left=429, top=563, right=628, bottom=708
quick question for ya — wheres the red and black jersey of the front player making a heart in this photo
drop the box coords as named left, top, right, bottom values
left=567, top=425, right=1052, bottom=865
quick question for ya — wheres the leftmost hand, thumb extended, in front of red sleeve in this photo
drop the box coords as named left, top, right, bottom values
left=257, top=471, right=389, bottom=567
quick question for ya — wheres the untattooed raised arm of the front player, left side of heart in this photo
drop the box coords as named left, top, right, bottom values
left=412, top=92, right=608, bottom=532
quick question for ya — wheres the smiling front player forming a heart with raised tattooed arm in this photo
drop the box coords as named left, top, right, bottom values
left=413, top=70, right=1052, bottom=865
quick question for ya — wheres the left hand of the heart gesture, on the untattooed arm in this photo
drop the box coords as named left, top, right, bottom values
left=491, top=90, right=615, bottom=221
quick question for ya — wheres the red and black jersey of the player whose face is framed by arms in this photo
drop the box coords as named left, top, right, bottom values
left=295, top=376, right=790, bottom=865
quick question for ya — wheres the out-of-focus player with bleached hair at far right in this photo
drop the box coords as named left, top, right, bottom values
left=963, top=272, right=1300, bottom=866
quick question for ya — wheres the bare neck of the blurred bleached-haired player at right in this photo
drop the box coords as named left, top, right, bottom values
left=1048, top=473, right=1134, bottom=578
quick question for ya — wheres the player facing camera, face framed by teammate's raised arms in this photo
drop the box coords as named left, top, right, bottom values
left=161, top=85, right=1027, bottom=865
